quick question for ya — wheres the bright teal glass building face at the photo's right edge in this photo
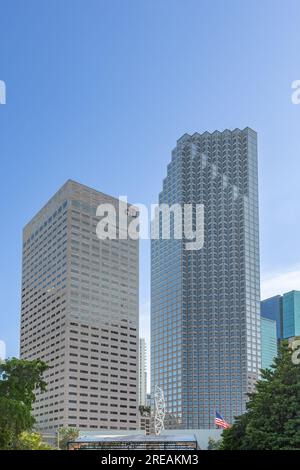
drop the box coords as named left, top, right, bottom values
left=282, top=290, right=300, bottom=338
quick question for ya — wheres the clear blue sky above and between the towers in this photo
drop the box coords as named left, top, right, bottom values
left=0, top=0, right=300, bottom=366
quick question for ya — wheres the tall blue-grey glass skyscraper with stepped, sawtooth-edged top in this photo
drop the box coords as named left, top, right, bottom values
left=151, top=128, right=261, bottom=429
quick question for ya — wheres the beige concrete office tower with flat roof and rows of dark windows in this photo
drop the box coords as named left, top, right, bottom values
left=21, top=181, right=139, bottom=432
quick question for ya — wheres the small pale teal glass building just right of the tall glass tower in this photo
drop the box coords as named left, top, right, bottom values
left=261, top=316, right=278, bottom=369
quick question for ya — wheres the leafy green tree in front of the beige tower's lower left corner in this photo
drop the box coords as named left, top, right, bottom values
left=0, top=358, right=48, bottom=449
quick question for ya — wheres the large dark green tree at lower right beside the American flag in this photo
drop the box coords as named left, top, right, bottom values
left=221, top=341, right=300, bottom=450
